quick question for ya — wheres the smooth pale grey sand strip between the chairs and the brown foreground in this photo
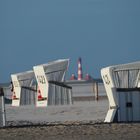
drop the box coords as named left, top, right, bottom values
left=6, top=100, right=108, bottom=123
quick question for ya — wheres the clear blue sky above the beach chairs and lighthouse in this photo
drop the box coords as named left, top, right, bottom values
left=0, top=0, right=140, bottom=83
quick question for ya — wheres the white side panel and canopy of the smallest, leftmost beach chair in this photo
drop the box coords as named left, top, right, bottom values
left=11, top=71, right=35, bottom=106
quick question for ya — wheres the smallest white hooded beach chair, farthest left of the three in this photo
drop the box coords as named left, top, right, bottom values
left=11, top=71, right=37, bottom=106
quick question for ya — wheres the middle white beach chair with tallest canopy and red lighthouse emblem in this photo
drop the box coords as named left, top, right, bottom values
left=33, top=59, right=69, bottom=107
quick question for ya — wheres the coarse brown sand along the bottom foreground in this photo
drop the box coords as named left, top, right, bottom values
left=0, top=123, right=140, bottom=140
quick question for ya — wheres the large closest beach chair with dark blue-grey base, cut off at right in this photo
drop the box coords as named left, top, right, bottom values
left=101, top=61, right=140, bottom=122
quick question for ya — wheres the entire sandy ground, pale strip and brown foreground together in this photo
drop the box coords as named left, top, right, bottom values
left=0, top=100, right=140, bottom=140
